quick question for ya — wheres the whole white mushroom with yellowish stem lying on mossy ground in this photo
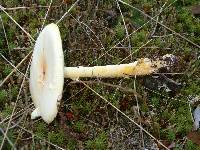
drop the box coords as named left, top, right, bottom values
left=30, top=23, right=165, bottom=123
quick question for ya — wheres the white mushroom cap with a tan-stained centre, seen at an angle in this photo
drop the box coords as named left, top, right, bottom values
left=30, top=23, right=64, bottom=123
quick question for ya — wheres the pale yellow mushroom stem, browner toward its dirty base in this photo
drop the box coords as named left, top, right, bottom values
left=64, top=58, right=166, bottom=80
